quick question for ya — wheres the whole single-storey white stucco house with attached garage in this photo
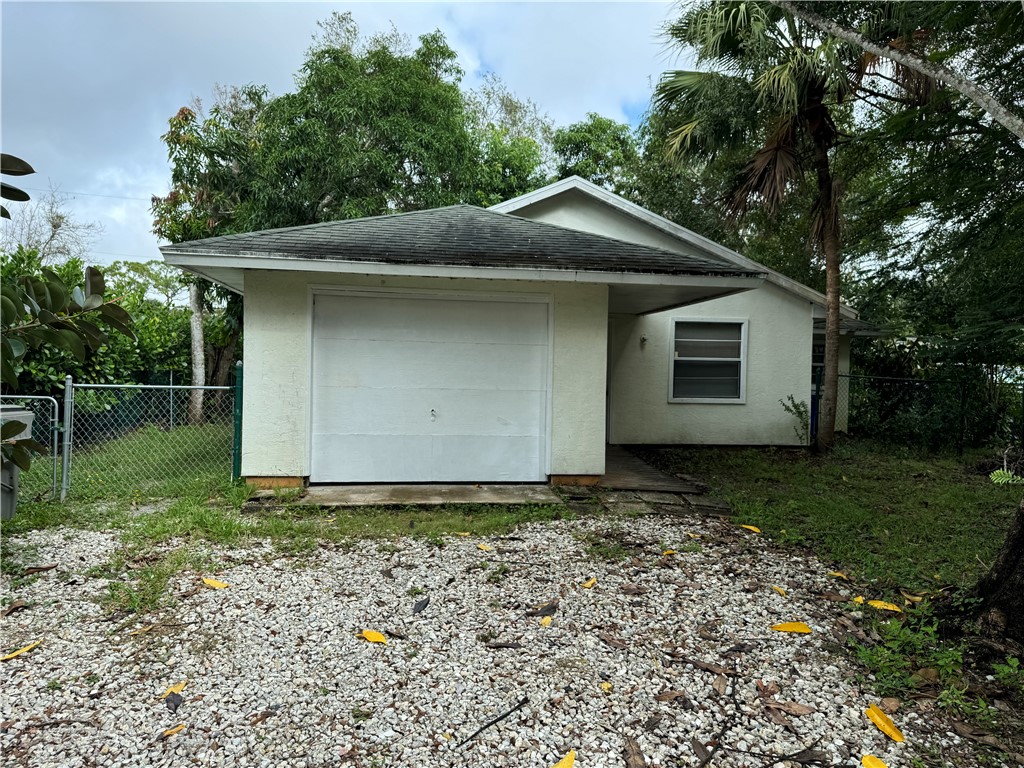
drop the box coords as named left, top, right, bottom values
left=161, top=177, right=859, bottom=485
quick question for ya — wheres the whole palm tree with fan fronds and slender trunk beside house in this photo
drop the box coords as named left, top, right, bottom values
left=655, top=0, right=857, bottom=450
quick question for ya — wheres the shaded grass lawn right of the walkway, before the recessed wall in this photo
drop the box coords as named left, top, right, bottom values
left=640, top=441, right=1022, bottom=591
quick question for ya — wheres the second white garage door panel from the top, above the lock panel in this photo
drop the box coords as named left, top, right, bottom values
left=317, top=339, right=548, bottom=390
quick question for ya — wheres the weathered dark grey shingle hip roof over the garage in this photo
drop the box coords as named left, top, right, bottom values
left=160, top=205, right=756, bottom=275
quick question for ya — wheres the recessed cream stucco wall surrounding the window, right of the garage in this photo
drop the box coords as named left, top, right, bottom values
left=609, top=285, right=813, bottom=445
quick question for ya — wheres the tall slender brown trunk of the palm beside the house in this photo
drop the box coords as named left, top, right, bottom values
left=814, top=140, right=840, bottom=451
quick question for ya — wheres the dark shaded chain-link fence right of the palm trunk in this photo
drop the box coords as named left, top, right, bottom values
left=815, top=375, right=1024, bottom=452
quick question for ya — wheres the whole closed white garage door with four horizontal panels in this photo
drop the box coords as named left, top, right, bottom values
left=309, top=294, right=549, bottom=482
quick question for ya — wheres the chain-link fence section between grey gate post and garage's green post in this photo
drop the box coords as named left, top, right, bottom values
left=61, top=384, right=240, bottom=498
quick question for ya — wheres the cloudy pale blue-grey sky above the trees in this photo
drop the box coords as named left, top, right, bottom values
left=6, top=0, right=679, bottom=264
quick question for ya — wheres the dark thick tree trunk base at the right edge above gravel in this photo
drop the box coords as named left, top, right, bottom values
left=974, top=499, right=1024, bottom=642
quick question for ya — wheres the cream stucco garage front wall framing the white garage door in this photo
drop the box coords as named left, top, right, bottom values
left=242, top=271, right=608, bottom=477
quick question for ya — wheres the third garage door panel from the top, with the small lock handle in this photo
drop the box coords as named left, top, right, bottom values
left=314, top=387, right=544, bottom=435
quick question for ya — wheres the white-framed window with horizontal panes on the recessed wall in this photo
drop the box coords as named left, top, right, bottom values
left=670, top=321, right=746, bottom=402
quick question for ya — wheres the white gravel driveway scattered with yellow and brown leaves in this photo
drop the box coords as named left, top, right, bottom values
left=0, top=516, right=974, bottom=768
